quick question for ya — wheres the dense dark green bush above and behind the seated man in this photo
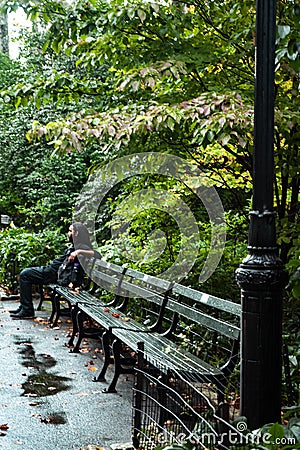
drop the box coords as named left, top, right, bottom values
left=0, top=104, right=89, bottom=230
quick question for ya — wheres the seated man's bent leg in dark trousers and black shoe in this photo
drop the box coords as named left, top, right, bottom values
left=12, top=267, right=46, bottom=318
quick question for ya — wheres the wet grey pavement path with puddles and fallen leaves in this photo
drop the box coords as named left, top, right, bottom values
left=0, top=300, right=132, bottom=450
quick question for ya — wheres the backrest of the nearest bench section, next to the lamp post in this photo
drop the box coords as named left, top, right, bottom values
left=164, top=283, right=241, bottom=376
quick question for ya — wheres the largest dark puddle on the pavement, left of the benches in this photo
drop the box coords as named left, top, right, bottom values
left=15, top=340, right=70, bottom=398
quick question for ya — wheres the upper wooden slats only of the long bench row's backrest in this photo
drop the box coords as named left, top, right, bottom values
left=88, top=259, right=241, bottom=328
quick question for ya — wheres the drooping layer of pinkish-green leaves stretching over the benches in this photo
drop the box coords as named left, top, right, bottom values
left=27, top=93, right=253, bottom=151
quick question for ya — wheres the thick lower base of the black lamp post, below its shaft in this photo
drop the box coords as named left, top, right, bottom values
left=236, top=247, right=287, bottom=430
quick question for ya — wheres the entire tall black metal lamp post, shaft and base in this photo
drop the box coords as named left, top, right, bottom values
left=236, top=0, right=286, bottom=429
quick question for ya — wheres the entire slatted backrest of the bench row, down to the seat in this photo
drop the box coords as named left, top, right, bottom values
left=81, top=259, right=241, bottom=375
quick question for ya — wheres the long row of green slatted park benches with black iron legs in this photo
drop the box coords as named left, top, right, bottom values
left=44, top=260, right=241, bottom=400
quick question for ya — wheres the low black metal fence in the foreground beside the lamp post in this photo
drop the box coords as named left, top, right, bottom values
left=133, top=357, right=243, bottom=450
